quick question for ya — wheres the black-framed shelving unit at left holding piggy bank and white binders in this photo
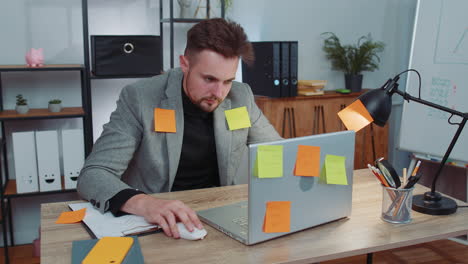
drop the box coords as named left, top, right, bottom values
left=0, top=0, right=93, bottom=263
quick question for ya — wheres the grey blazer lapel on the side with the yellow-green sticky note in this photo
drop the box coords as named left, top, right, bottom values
left=213, top=99, right=232, bottom=186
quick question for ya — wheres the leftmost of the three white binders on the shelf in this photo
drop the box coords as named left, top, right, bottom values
left=11, top=131, right=39, bottom=193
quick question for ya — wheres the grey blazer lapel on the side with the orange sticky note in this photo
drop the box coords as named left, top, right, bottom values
left=161, top=70, right=184, bottom=191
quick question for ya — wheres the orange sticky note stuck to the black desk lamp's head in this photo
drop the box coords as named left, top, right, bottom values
left=338, top=100, right=374, bottom=132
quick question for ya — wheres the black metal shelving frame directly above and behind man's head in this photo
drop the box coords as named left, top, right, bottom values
left=159, top=0, right=225, bottom=68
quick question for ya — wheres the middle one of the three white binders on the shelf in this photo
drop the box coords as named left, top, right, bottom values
left=36, top=130, right=62, bottom=192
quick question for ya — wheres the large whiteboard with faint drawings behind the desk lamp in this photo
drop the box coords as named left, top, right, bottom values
left=394, top=0, right=468, bottom=161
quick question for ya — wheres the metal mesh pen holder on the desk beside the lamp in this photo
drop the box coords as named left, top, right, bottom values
left=382, top=186, right=414, bottom=224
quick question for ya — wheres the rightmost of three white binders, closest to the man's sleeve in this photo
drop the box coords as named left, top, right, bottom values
left=62, top=129, right=84, bottom=189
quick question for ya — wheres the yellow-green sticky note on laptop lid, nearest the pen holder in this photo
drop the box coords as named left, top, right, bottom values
left=320, top=155, right=348, bottom=185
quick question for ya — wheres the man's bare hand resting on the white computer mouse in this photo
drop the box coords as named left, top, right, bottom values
left=120, top=194, right=203, bottom=238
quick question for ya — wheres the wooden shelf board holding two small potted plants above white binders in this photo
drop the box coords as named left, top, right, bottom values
left=0, top=107, right=85, bottom=120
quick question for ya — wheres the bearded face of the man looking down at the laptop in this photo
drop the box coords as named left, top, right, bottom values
left=180, top=50, right=239, bottom=112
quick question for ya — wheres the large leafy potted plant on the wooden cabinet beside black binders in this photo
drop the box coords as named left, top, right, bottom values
left=322, top=32, right=385, bottom=92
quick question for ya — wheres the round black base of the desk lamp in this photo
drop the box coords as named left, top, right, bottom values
left=412, top=192, right=458, bottom=215
